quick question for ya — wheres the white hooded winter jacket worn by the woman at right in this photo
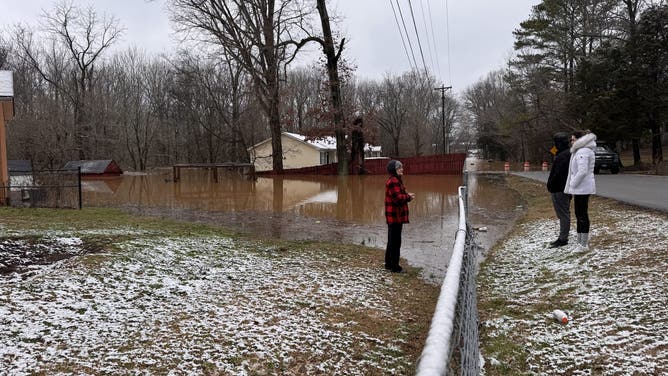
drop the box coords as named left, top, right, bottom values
left=564, top=133, right=596, bottom=195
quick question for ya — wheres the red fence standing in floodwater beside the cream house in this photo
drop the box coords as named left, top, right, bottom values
left=258, top=153, right=466, bottom=175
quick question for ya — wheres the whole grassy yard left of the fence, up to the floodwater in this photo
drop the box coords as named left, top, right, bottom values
left=0, top=208, right=439, bottom=375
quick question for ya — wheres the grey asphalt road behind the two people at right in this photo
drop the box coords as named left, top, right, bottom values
left=513, top=171, right=668, bottom=212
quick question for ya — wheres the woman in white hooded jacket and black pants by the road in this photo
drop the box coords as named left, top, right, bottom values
left=564, top=131, right=596, bottom=248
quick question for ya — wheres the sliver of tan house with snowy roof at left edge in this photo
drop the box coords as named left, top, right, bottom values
left=0, top=71, right=14, bottom=205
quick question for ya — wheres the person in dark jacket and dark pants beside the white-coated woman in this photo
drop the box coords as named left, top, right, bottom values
left=547, top=132, right=571, bottom=248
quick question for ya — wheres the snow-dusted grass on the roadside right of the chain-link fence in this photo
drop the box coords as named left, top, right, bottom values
left=481, top=206, right=668, bottom=375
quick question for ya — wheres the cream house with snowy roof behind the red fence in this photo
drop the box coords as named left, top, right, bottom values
left=248, top=132, right=381, bottom=171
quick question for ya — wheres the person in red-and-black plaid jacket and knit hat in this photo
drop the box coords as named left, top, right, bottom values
left=385, top=160, right=415, bottom=273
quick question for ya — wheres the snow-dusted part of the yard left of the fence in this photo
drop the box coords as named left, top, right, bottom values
left=0, top=232, right=412, bottom=375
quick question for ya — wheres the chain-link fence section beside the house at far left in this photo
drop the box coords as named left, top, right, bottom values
left=0, top=169, right=82, bottom=209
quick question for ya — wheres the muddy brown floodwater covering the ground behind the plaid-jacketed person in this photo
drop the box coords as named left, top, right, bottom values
left=83, top=170, right=517, bottom=281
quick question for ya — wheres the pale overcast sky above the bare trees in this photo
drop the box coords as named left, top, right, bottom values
left=0, top=0, right=540, bottom=92
